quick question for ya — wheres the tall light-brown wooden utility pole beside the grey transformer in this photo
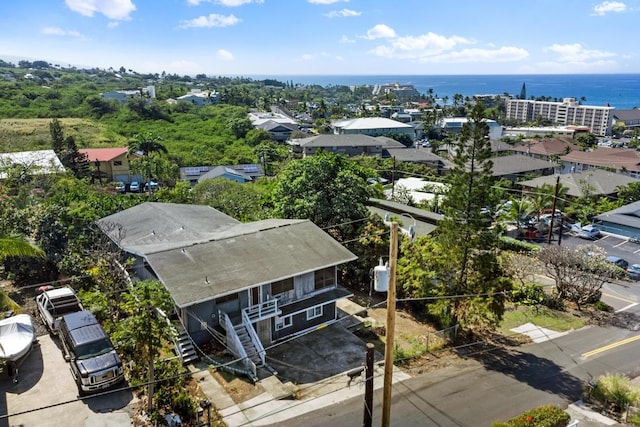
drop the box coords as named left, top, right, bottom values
left=382, top=221, right=398, bottom=427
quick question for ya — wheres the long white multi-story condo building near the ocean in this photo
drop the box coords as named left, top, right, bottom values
left=507, top=98, right=615, bottom=136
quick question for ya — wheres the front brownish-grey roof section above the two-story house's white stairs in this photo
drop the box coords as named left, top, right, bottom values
left=147, top=221, right=357, bottom=307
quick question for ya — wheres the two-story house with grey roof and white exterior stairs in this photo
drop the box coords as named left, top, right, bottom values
left=98, top=202, right=356, bottom=376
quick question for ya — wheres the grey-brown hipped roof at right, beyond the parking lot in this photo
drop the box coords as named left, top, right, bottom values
left=518, top=169, right=639, bottom=197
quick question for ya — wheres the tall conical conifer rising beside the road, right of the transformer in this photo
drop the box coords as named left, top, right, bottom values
left=402, top=103, right=510, bottom=330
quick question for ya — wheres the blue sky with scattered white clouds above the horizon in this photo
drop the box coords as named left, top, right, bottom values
left=0, top=0, right=640, bottom=76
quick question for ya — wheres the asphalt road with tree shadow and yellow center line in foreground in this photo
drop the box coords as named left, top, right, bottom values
left=287, top=327, right=640, bottom=427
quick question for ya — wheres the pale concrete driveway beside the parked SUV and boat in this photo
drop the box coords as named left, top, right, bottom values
left=0, top=335, right=133, bottom=427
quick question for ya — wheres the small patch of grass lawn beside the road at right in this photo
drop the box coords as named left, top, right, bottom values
left=498, top=306, right=586, bottom=335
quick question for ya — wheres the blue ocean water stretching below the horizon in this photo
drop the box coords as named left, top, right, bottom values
left=251, top=74, right=640, bottom=110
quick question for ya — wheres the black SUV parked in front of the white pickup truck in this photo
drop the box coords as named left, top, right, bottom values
left=59, top=311, right=124, bottom=392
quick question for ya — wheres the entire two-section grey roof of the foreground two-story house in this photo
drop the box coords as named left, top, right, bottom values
left=98, top=203, right=357, bottom=307
